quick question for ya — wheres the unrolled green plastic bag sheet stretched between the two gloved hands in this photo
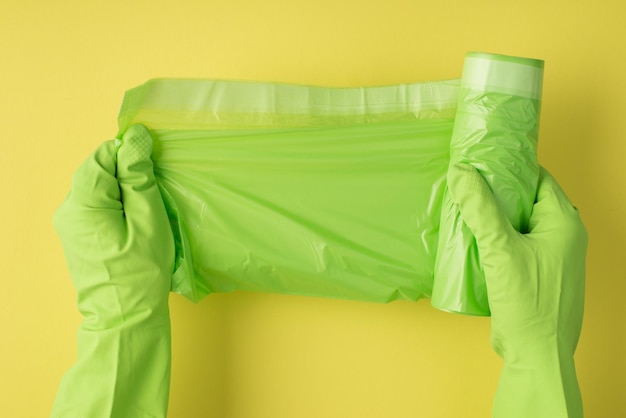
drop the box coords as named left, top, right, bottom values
left=119, top=52, right=538, bottom=311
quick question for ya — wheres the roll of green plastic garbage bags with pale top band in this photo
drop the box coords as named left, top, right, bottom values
left=431, top=53, right=543, bottom=315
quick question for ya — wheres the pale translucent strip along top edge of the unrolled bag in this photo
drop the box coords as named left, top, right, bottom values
left=118, top=79, right=459, bottom=134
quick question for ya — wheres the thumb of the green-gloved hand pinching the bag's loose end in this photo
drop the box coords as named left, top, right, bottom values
left=117, top=124, right=167, bottom=236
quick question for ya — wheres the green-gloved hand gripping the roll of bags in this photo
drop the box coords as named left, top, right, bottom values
left=448, top=165, right=587, bottom=418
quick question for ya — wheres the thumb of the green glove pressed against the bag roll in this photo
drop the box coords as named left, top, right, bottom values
left=448, top=164, right=518, bottom=262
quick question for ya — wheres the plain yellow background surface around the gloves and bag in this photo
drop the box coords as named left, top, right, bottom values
left=0, top=0, right=626, bottom=418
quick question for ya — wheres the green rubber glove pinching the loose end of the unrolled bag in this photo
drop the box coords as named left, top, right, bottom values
left=52, top=125, right=174, bottom=418
